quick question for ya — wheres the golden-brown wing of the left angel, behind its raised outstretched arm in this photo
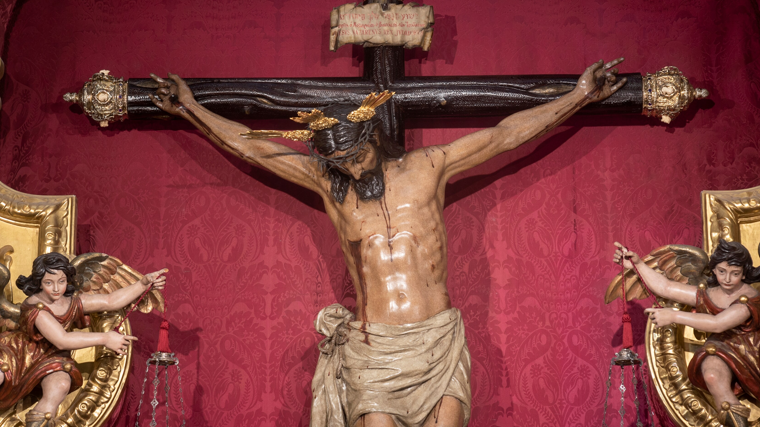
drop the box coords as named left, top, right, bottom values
left=71, top=252, right=164, bottom=313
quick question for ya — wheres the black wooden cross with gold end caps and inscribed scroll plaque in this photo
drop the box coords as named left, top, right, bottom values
left=64, top=0, right=708, bottom=149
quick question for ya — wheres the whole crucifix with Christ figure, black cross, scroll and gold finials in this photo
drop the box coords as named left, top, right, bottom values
left=66, top=0, right=705, bottom=427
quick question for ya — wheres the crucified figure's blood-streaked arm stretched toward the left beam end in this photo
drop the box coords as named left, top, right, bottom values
left=150, top=73, right=327, bottom=195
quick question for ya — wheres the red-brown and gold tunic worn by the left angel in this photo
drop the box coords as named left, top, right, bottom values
left=0, top=294, right=89, bottom=412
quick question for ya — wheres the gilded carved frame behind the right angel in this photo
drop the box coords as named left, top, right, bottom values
left=645, top=187, right=760, bottom=427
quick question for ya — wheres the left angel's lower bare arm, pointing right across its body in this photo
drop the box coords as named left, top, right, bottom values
left=34, top=310, right=137, bottom=354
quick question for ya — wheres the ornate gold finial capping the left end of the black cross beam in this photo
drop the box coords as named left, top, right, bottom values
left=63, top=70, right=127, bottom=127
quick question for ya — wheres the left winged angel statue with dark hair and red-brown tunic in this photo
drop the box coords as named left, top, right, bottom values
left=0, top=252, right=166, bottom=427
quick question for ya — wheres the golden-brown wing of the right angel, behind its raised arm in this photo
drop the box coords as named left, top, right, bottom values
left=604, top=245, right=710, bottom=304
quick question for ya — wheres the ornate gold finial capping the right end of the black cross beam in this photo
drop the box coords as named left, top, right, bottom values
left=641, top=66, right=710, bottom=124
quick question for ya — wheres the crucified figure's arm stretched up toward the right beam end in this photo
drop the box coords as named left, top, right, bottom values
left=441, top=58, right=627, bottom=182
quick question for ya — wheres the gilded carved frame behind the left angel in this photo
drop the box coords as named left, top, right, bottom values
left=0, top=183, right=134, bottom=427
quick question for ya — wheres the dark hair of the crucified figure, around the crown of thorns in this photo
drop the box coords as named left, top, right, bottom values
left=312, top=104, right=406, bottom=203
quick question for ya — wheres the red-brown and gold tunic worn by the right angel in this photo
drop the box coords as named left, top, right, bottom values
left=689, top=288, right=760, bottom=399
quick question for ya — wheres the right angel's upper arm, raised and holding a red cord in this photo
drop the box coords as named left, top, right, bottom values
left=613, top=242, right=697, bottom=306
